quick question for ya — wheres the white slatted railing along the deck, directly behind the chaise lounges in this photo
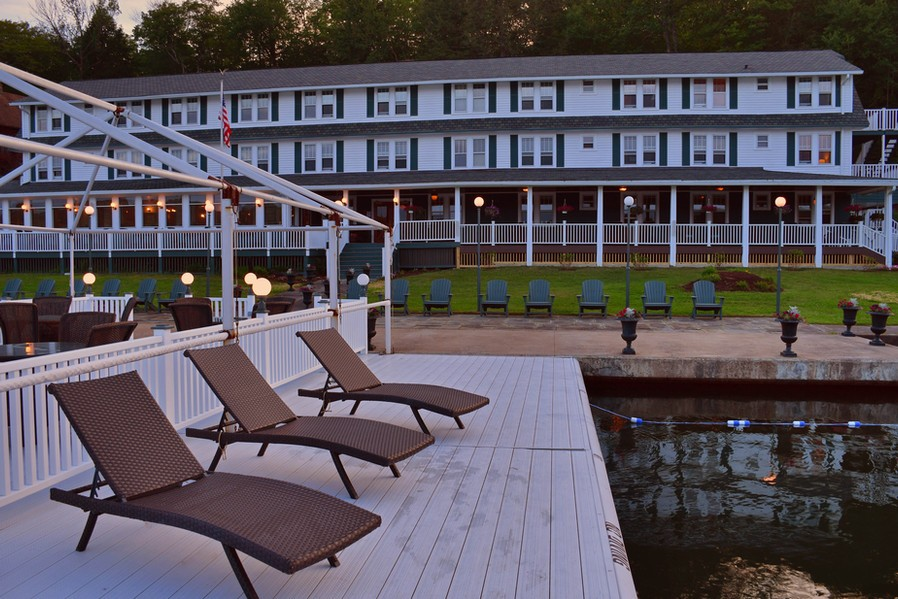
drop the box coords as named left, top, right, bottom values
left=0, top=298, right=368, bottom=507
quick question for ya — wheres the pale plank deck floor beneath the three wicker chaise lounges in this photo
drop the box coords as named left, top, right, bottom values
left=0, top=355, right=635, bottom=598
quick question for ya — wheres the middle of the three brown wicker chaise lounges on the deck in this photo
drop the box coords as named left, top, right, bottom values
left=184, top=344, right=433, bottom=499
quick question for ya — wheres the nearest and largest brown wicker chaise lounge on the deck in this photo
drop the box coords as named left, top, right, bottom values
left=49, top=371, right=381, bottom=597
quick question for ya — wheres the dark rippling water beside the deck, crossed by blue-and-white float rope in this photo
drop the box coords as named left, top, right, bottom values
left=592, top=398, right=898, bottom=599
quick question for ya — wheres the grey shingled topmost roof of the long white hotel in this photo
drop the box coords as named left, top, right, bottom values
left=21, top=50, right=863, bottom=100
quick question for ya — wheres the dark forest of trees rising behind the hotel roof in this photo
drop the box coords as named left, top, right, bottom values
left=0, top=0, right=898, bottom=107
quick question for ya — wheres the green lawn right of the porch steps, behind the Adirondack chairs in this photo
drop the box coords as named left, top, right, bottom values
left=370, top=266, right=898, bottom=324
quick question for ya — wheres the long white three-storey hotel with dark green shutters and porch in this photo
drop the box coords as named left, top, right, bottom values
left=0, top=51, right=898, bottom=270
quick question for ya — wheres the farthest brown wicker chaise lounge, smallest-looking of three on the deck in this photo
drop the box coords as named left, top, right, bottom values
left=296, top=329, right=490, bottom=434
